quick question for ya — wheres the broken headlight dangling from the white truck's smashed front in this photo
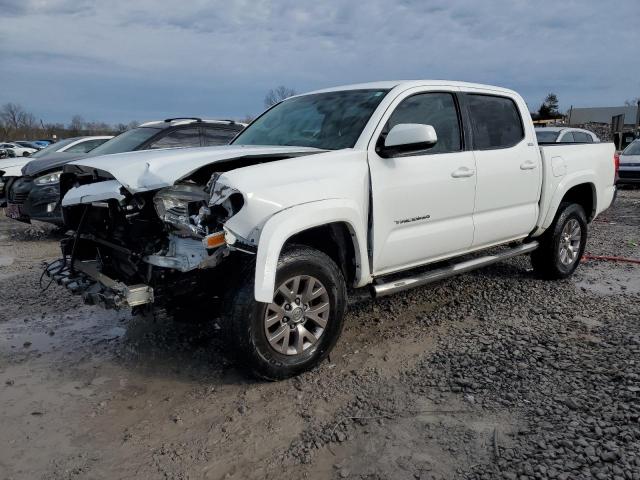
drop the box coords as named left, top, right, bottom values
left=153, top=185, right=209, bottom=238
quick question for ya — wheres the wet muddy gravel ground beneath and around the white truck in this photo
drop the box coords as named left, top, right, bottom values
left=0, top=190, right=640, bottom=479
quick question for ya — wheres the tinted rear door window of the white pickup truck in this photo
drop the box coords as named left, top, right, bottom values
left=466, top=93, right=524, bottom=150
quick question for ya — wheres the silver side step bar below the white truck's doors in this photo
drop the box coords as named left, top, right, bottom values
left=373, top=241, right=538, bottom=297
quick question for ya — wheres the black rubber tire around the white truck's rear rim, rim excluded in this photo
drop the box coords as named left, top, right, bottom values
left=531, top=203, right=587, bottom=280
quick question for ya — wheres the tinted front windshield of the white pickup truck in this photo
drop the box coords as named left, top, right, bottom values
left=232, top=90, right=388, bottom=150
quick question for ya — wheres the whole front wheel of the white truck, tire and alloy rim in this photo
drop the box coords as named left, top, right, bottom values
left=224, top=246, right=347, bottom=380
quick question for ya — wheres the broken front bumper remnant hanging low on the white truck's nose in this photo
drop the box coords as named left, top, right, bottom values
left=45, top=260, right=154, bottom=309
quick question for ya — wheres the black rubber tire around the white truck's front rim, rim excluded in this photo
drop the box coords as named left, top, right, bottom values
left=222, top=245, right=347, bottom=381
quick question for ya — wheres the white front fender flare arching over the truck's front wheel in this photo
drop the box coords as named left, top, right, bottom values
left=254, top=199, right=370, bottom=303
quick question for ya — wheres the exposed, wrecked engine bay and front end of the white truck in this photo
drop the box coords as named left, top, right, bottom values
left=45, top=155, right=316, bottom=308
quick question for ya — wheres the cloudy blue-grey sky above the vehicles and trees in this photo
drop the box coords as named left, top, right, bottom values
left=0, top=0, right=640, bottom=123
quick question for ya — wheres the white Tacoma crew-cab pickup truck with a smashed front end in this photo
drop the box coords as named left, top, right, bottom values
left=47, top=81, right=615, bottom=379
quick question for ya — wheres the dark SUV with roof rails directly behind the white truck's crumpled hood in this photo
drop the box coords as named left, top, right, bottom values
left=6, top=118, right=245, bottom=225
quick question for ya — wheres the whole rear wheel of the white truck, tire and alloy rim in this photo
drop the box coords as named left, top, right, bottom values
left=531, top=203, right=587, bottom=280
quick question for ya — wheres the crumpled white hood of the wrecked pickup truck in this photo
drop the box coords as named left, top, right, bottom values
left=71, top=145, right=324, bottom=193
